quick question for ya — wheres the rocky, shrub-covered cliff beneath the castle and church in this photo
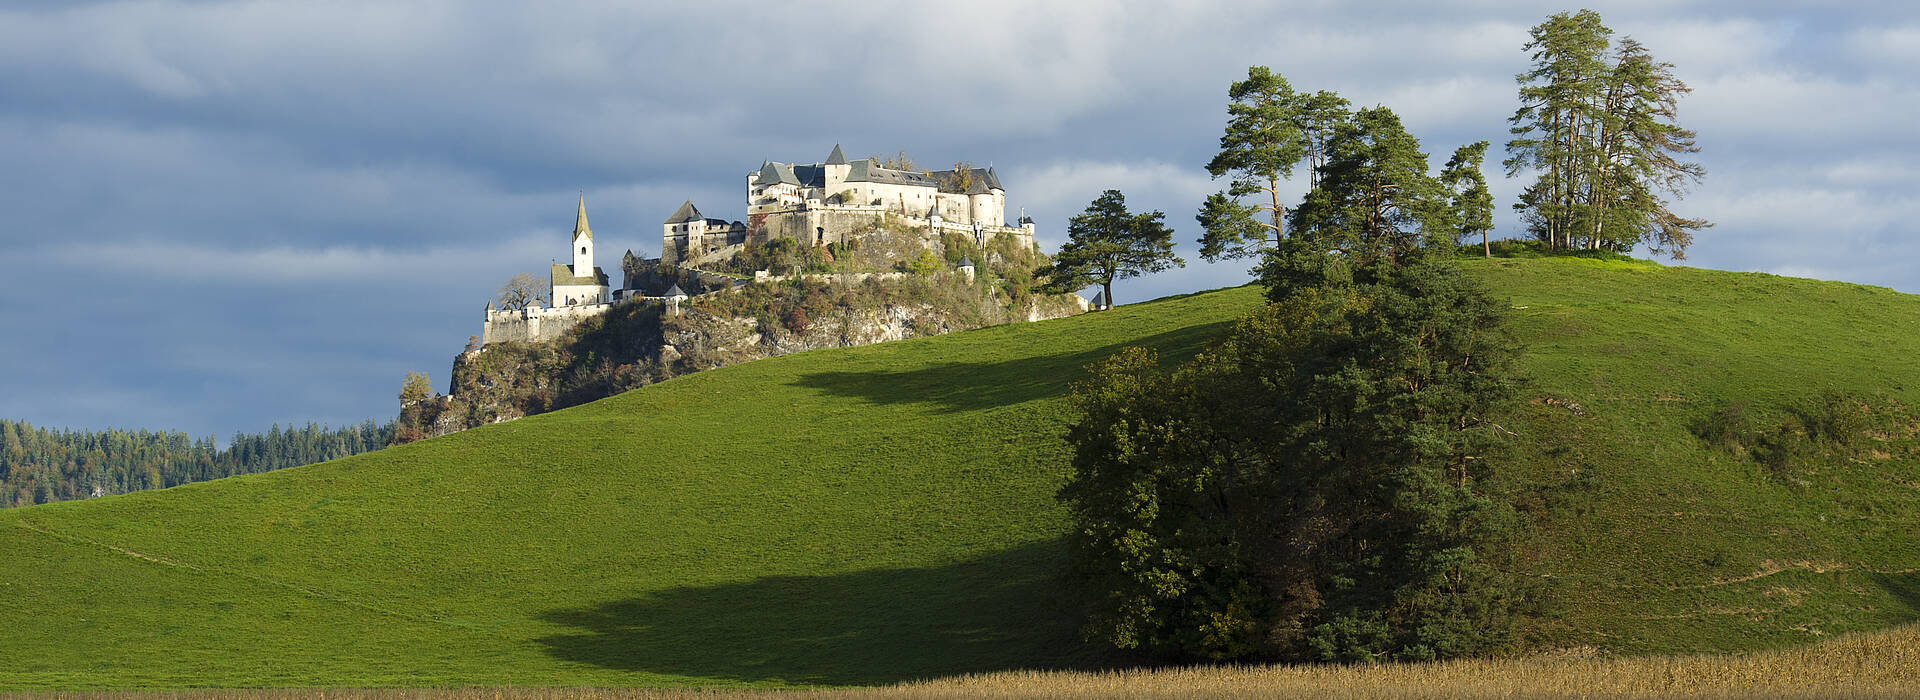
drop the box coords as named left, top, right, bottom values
left=397, top=234, right=1083, bottom=441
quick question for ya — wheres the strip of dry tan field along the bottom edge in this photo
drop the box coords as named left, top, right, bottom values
left=6, top=625, right=1920, bottom=700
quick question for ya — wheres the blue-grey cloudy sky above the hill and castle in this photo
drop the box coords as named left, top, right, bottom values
left=0, top=0, right=1920, bottom=437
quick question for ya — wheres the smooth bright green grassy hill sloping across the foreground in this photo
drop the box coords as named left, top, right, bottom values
left=0, top=259, right=1920, bottom=688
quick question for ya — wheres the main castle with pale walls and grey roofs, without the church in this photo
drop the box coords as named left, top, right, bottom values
left=660, top=144, right=1033, bottom=265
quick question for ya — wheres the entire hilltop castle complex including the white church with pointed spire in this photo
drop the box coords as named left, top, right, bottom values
left=480, top=144, right=1033, bottom=345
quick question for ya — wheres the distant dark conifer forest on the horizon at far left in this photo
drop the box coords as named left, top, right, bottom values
left=0, top=418, right=394, bottom=508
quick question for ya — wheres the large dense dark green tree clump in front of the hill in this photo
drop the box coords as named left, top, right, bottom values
left=1060, top=73, right=1526, bottom=662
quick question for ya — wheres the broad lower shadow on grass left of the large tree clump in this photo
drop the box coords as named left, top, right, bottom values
left=540, top=541, right=1077, bottom=685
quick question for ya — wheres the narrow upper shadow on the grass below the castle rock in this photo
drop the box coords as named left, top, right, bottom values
left=795, top=320, right=1231, bottom=410
